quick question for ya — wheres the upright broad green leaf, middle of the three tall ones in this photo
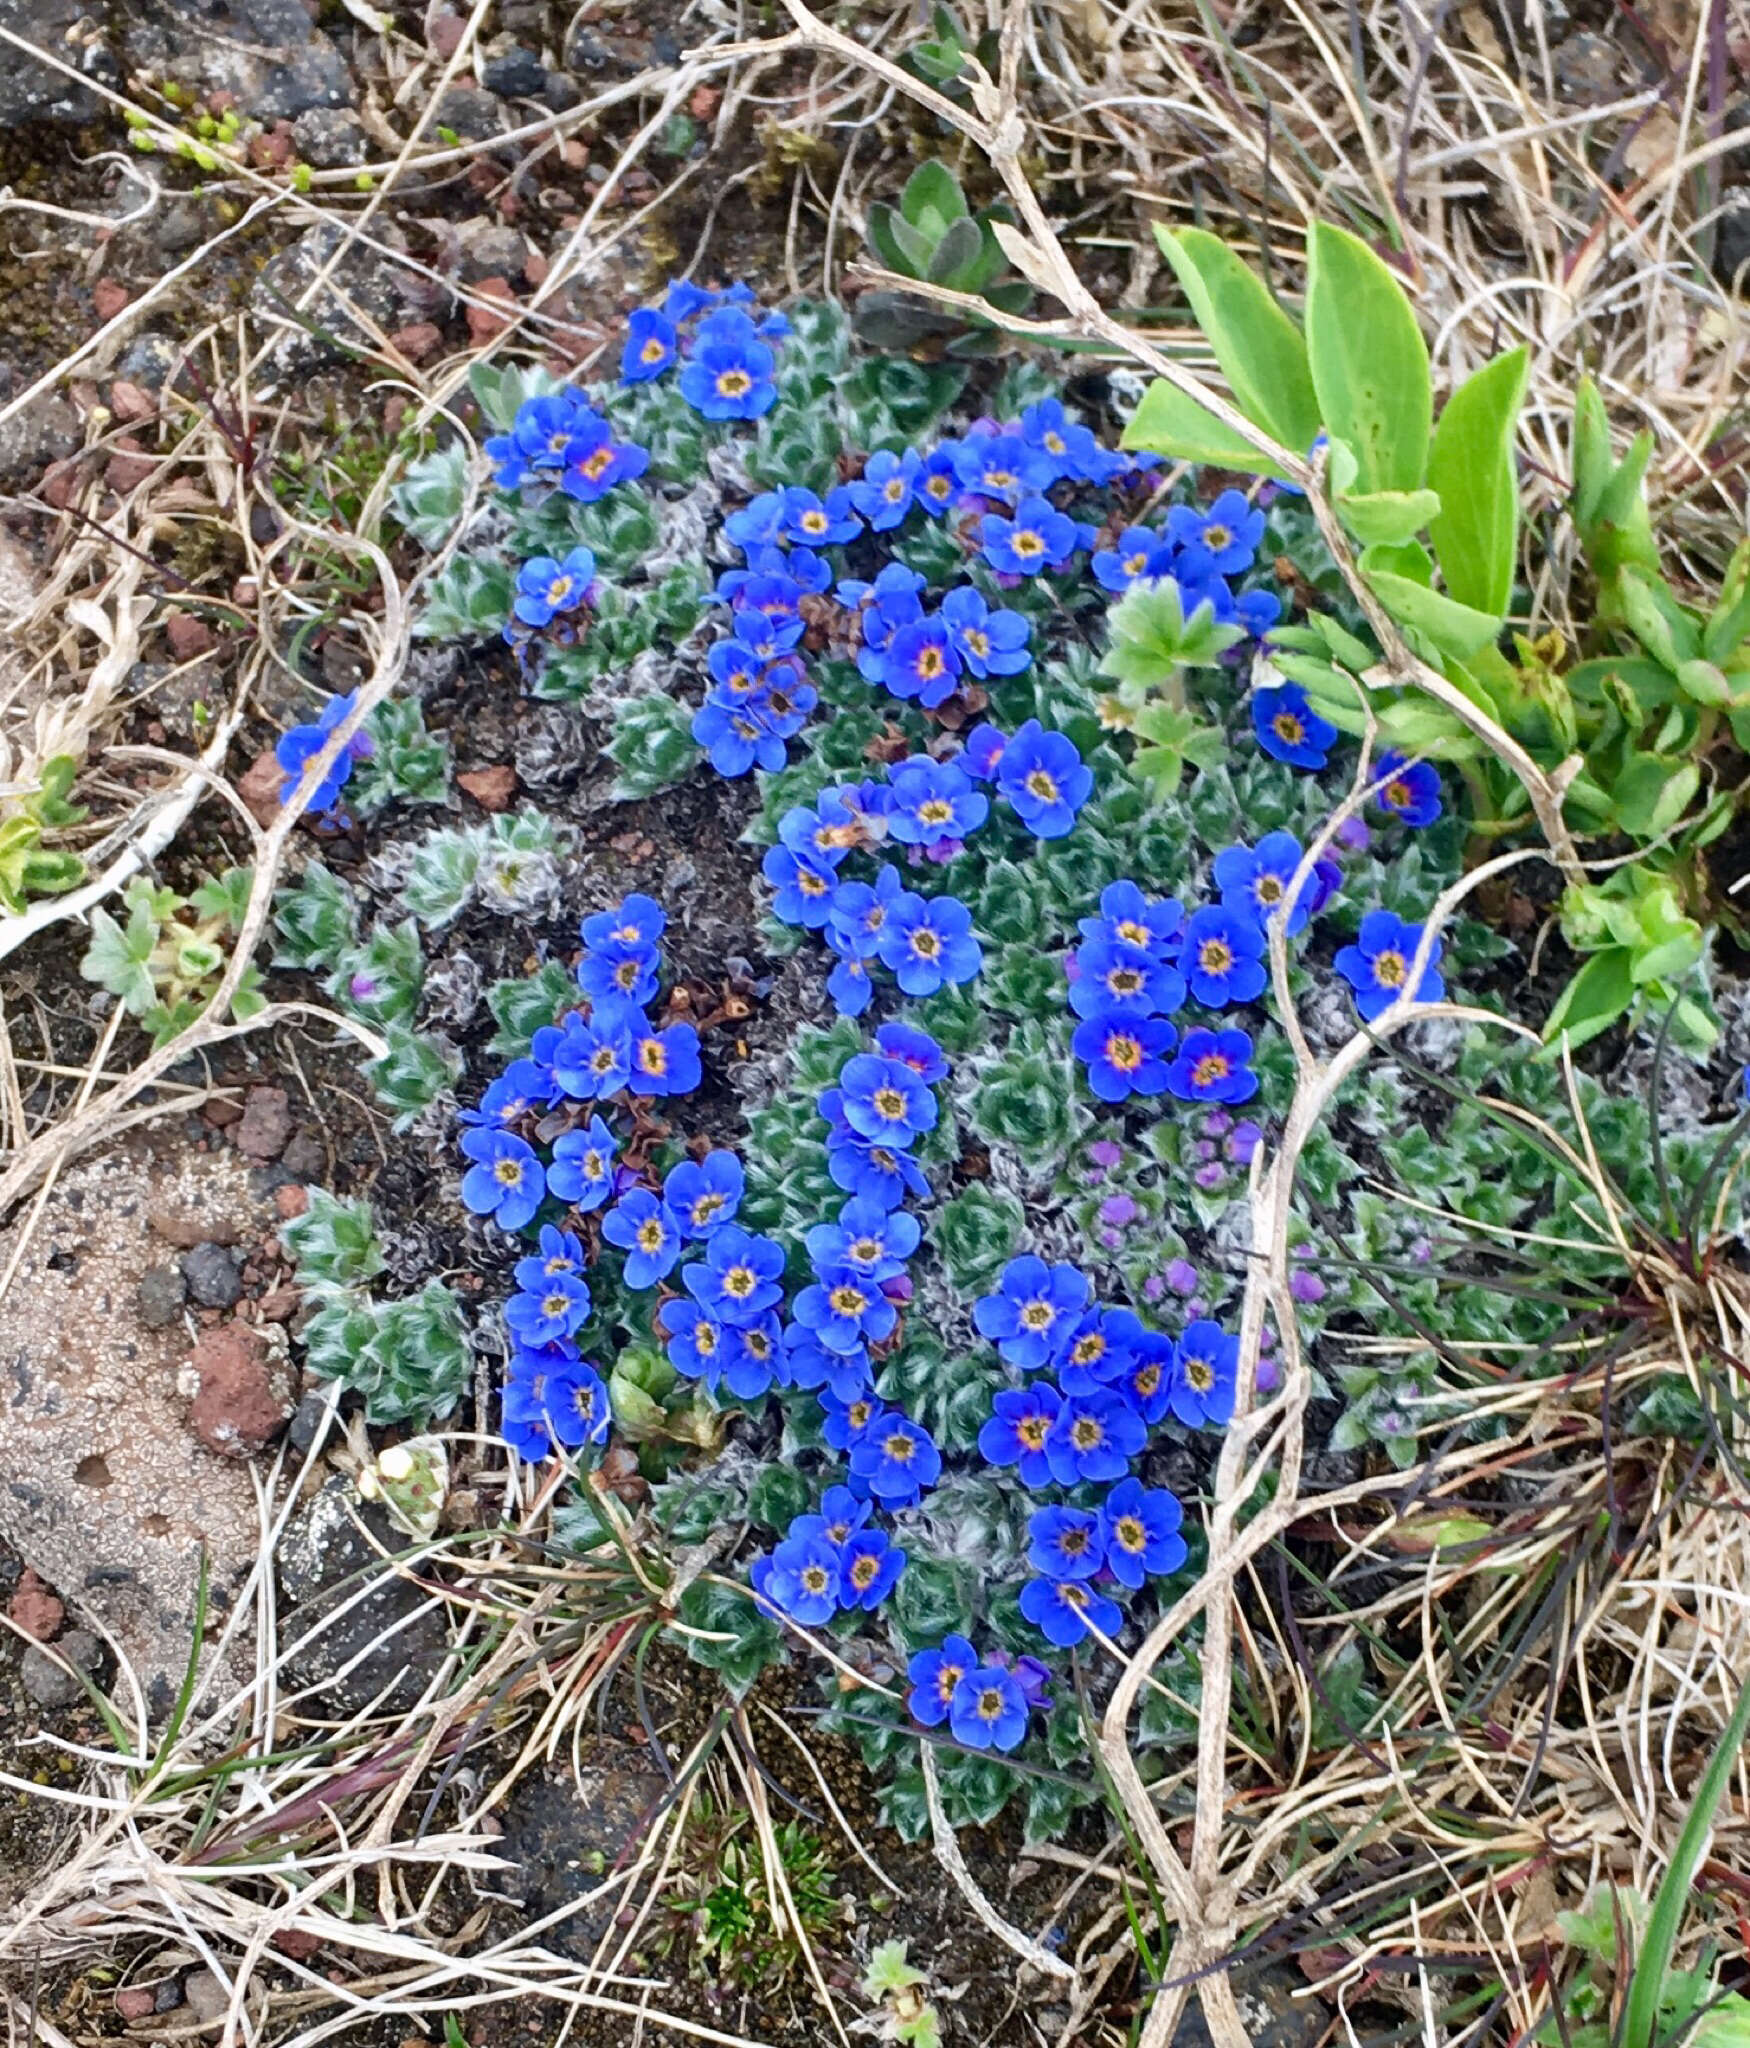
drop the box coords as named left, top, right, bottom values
left=1305, top=221, right=1434, bottom=494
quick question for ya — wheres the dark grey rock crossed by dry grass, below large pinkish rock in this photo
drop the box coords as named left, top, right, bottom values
left=275, top=1475, right=447, bottom=1718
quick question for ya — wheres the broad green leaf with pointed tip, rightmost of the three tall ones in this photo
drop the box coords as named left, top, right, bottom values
left=1428, top=348, right=1529, bottom=618
